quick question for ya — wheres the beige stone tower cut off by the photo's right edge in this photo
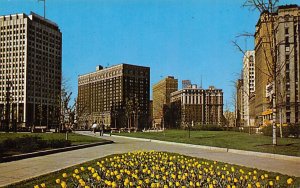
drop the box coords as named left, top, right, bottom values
left=275, top=5, right=300, bottom=124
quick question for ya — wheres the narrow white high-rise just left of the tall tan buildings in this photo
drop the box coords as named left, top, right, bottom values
left=242, top=51, right=255, bottom=126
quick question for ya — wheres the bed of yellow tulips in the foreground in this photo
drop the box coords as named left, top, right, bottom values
left=35, top=151, right=293, bottom=188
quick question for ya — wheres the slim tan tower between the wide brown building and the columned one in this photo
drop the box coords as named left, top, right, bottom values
left=152, top=76, right=178, bottom=127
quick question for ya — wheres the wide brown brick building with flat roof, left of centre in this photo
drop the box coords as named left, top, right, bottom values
left=77, top=64, right=150, bottom=129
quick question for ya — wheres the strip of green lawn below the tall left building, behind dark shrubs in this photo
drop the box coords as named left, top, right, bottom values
left=0, top=133, right=103, bottom=145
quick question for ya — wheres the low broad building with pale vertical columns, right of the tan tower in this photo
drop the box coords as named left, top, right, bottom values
left=171, top=86, right=223, bottom=127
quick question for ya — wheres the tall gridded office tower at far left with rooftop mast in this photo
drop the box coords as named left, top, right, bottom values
left=0, top=13, right=62, bottom=128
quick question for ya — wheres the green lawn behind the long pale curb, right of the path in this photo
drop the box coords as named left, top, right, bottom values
left=114, top=130, right=300, bottom=156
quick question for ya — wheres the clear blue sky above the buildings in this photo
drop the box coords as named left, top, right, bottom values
left=0, top=0, right=298, bottom=109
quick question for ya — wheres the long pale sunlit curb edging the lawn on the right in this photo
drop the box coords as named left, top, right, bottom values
left=111, top=135, right=300, bottom=162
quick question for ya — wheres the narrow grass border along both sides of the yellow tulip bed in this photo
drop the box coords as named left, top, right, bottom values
left=4, top=152, right=300, bottom=188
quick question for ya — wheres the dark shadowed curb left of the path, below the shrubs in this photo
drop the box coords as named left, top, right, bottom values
left=0, top=140, right=114, bottom=163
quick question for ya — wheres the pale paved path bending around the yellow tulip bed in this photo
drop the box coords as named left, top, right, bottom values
left=0, top=132, right=300, bottom=187
